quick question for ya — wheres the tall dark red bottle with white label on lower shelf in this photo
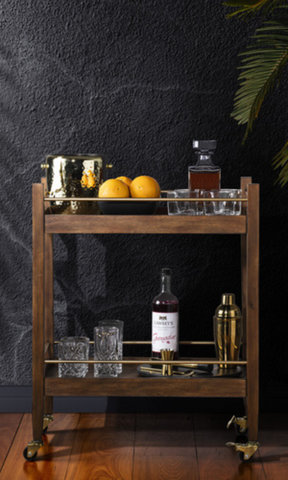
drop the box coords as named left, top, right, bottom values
left=152, top=268, right=179, bottom=360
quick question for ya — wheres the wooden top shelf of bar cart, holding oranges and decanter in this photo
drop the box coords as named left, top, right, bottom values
left=42, top=177, right=252, bottom=234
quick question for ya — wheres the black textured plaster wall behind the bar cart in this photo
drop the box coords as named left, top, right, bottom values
left=0, top=0, right=288, bottom=400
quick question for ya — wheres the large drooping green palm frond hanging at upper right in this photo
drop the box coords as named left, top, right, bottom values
left=231, top=6, right=288, bottom=141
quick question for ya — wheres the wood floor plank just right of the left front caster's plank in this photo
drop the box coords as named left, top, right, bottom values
left=66, top=413, right=135, bottom=480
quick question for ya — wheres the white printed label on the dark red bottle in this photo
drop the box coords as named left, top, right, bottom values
left=152, top=312, right=179, bottom=352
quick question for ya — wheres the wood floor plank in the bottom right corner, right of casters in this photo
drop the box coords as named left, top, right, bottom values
left=259, top=414, right=288, bottom=480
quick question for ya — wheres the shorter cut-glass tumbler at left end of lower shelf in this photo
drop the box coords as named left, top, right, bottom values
left=58, top=337, right=89, bottom=378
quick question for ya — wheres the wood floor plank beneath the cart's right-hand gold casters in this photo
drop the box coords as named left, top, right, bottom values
left=193, top=414, right=266, bottom=480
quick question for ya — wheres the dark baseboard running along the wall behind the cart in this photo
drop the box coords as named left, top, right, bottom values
left=0, top=386, right=288, bottom=414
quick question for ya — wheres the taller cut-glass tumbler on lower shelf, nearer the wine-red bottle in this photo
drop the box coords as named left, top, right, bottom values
left=94, top=326, right=119, bottom=377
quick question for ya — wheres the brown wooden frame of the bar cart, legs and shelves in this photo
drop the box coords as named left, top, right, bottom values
left=24, top=177, right=259, bottom=460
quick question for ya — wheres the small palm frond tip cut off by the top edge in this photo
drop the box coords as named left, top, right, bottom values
left=223, top=0, right=285, bottom=18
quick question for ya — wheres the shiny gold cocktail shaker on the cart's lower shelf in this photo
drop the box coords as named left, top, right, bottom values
left=213, top=293, right=242, bottom=371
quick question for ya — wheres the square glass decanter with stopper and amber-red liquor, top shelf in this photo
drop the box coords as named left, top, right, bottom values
left=188, top=140, right=221, bottom=190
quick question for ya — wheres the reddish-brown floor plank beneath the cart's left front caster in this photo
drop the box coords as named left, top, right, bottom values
left=1, top=414, right=79, bottom=480
